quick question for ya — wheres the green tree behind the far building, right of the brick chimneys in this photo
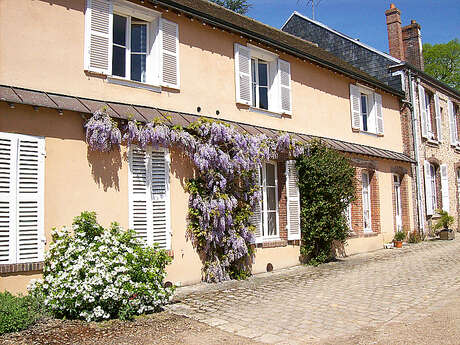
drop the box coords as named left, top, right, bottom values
left=423, top=38, right=460, bottom=91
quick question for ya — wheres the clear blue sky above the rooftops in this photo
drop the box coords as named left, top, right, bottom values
left=248, top=0, right=460, bottom=52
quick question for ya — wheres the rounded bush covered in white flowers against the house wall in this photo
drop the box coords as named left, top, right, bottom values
left=29, top=212, right=174, bottom=321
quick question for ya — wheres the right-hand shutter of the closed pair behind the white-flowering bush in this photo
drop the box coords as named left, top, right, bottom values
left=150, top=150, right=171, bottom=249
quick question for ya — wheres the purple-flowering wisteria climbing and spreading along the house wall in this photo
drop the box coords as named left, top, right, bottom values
left=85, top=109, right=304, bottom=282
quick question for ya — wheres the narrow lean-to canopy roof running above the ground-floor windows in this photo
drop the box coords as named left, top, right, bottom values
left=0, top=85, right=415, bottom=163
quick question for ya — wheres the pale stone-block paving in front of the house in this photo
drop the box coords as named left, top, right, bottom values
left=168, top=240, right=460, bottom=344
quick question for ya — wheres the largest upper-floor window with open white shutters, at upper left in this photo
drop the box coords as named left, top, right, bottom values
left=85, top=0, right=180, bottom=91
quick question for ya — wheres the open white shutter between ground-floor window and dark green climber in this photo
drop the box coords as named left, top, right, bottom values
left=286, top=160, right=301, bottom=240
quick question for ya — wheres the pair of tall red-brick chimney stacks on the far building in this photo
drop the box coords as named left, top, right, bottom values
left=385, top=4, right=424, bottom=71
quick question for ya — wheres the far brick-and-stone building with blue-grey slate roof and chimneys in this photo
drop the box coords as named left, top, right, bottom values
left=283, top=4, right=460, bottom=233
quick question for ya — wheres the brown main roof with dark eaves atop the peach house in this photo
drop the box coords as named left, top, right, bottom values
left=149, top=0, right=404, bottom=97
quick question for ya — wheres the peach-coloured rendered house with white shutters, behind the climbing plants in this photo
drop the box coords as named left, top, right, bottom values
left=0, top=0, right=414, bottom=292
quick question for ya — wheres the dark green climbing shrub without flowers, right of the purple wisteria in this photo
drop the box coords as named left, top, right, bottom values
left=296, top=141, right=355, bottom=265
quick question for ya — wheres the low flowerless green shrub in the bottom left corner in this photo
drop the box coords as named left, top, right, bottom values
left=0, top=291, right=43, bottom=334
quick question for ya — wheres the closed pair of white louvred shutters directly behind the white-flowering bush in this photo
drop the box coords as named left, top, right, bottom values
left=129, top=146, right=171, bottom=249
